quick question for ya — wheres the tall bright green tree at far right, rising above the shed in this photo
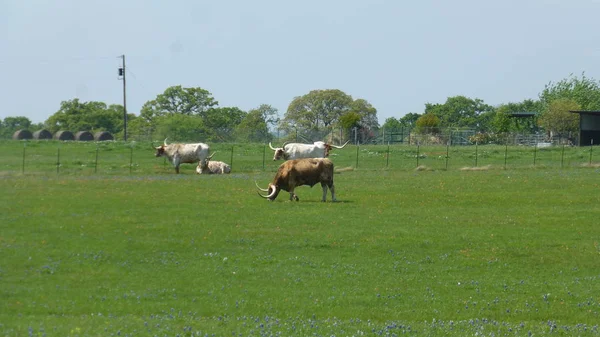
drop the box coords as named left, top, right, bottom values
left=540, top=73, right=600, bottom=110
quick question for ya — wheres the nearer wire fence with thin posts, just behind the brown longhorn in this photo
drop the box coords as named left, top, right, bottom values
left=0, top=141, right=598, bottom=175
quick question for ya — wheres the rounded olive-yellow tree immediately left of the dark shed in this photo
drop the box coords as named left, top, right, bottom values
left=538, top=98, right=581, bottom=137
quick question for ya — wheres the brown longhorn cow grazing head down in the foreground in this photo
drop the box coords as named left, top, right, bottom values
left=254, top=158, right=336, bottom=202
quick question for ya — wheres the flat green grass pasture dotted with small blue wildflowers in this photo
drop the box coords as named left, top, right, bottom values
left=0, top=142, right=600, bottom=336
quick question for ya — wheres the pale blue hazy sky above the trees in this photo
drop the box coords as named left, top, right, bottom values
left=0, top=0, right=600, bottom=124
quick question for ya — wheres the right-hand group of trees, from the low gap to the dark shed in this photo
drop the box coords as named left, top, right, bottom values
left=383, top=74, right=600, bottom=140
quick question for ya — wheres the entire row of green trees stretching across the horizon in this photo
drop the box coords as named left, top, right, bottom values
left=0, top=74, right=600, bottom=143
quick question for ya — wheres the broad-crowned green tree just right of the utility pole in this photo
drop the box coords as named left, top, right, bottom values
left=140, top=85, right=219, bottom=121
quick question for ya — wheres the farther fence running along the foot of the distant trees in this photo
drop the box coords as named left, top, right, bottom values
left=5, top=126, right=579, bottom=146
